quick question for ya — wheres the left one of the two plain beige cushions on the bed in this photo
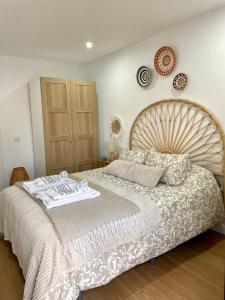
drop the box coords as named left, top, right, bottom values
left=103, top=159, right=133, bottom=179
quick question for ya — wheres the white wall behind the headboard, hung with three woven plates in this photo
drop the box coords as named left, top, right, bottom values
left=87, top=8, right=225, bottom=155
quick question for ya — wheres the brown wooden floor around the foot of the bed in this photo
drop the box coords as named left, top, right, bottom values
left=0, top=231, right=225, bottom=300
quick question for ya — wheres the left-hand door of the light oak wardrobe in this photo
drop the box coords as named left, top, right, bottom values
left=41, top=78, right=73, bottom=175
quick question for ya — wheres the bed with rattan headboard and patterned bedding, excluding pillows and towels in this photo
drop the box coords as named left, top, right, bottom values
left=0, top=99, right=224, bottom=300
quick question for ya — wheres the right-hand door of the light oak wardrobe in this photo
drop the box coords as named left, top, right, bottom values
left=70, top=80, right=98, bottom=172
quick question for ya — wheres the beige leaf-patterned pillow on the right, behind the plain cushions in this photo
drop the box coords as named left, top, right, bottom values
left=145, top=149, right=191, bottom=186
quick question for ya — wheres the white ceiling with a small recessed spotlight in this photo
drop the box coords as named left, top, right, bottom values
left=0, top=0, right=225, bottom=63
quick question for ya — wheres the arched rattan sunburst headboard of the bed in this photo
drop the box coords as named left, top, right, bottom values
left=130, top=99, right=225, bottom=202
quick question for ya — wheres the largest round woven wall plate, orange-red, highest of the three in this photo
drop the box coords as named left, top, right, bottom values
left=154, top=46, right=176, bottom=76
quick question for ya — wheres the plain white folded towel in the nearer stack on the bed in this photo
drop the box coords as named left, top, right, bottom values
left=37, top=187, right=100, bottom=209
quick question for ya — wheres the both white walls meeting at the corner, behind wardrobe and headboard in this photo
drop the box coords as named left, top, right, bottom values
left=0, top=5, right=225, bottom=186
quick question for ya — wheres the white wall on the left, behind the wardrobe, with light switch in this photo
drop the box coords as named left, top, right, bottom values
left=0, top=56, right=85, bottom=188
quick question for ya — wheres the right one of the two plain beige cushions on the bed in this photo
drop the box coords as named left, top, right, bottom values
left=125, top=164, right=164, bottom=188
